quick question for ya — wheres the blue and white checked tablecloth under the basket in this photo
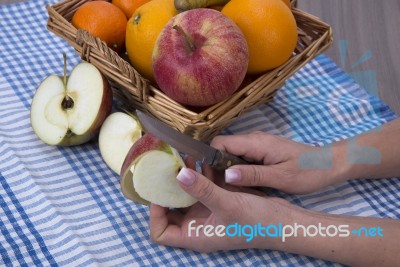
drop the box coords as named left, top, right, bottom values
left=0, top=0, right=400, bottom=266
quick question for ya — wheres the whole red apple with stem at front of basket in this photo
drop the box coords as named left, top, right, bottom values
left=153, top=8, right=249, bottom=106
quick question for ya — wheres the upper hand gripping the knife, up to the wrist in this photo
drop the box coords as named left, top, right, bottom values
left=211, top=132, right=347, bottom=194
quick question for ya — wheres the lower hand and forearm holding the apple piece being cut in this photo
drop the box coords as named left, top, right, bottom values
left=150, top=166, right=400, bottom=266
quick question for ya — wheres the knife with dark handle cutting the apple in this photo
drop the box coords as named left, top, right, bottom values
left=137, top=110, right=249, bottom=170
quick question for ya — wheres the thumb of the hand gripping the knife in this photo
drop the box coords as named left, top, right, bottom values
left=225, top=165, right=282, bottom=189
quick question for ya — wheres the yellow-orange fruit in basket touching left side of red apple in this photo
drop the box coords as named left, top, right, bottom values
left=125, top=0, right=178, bottom=80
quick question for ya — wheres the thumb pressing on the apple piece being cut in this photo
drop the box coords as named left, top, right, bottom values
left=176, top=168, right=229, bottom=214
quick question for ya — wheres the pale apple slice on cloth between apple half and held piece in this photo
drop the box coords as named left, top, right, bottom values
left=99, top=112, right=143, bottom=174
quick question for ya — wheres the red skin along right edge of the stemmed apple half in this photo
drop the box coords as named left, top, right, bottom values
left=58, top=73, right=113, bottom=146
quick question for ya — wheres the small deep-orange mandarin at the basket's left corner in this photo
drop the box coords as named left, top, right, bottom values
left=72, top=1, right=127, bottom=52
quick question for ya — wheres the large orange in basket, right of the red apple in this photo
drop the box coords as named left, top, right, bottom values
left=221, top=0, right=297, bottom=74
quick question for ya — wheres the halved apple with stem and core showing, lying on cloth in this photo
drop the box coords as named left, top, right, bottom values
left=31, top=56, right=112, bottom=146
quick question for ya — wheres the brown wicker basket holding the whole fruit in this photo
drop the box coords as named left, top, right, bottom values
left=47, top=0, right=332, bottom=141
